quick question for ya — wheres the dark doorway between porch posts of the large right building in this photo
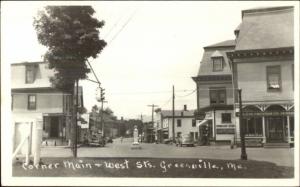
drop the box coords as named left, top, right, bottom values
left=268, top=117, right=284, bottom=142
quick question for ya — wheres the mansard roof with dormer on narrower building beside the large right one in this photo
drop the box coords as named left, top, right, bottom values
left=197, top=40, right=235, bottom=76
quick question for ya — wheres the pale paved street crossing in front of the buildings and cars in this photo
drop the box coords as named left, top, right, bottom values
left=41, top=138, right=294, bottom=166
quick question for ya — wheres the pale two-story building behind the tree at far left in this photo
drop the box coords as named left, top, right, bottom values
left=11, top=62, right=83, bottom=146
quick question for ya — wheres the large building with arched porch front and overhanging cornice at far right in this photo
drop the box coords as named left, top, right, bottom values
left=228, top=7, right=299, bottom=146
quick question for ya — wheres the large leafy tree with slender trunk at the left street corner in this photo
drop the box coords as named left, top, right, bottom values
left=33, top=6, right=106, bottom=157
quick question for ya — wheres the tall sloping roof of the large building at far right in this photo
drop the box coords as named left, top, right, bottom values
left=235, top=7, right=294, bottom=51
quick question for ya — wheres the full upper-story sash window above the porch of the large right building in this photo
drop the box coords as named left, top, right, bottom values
left=267, top=66, right=281, bottom=91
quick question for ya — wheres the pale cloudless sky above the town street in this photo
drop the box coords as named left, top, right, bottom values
left=1, top=1, right=295, bottom=119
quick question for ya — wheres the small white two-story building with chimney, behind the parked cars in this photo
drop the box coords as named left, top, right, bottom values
left=156, top=105, right=198, bottom=143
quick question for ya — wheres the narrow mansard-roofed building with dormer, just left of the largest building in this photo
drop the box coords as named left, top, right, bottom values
left=193, top=40, right=235, bottom=142
